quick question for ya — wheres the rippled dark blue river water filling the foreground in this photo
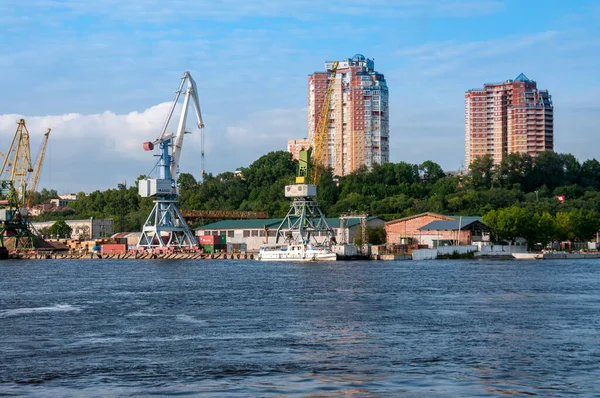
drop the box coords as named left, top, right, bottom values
left=0, top=260, right=600, bottom=397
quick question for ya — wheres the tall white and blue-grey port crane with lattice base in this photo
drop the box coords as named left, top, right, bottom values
left=137, top=72, right=204, bottom=250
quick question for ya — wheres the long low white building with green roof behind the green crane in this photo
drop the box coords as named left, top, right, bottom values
left=195, top=217, right=385, bottom=251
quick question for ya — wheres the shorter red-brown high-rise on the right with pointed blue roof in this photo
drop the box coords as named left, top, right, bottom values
left=465, top=73, right=554, bottom=166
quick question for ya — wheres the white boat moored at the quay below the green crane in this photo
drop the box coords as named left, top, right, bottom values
left=256, top=243, right=337, bottom=261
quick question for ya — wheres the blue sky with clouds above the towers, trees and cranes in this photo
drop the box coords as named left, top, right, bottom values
left=0, top=0, right=600, bottom=192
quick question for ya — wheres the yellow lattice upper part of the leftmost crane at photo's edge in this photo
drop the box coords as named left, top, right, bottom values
left=0, top=119, right=33, bottom=206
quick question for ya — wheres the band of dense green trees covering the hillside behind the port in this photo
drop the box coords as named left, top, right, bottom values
left=29, top=151, right=600, bottom=242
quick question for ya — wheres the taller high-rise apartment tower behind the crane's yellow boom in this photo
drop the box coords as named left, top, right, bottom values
left=308, top=54, right=390, bottom=176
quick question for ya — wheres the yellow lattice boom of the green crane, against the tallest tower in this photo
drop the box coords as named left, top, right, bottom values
left=311, top=61, right=339, bottom=185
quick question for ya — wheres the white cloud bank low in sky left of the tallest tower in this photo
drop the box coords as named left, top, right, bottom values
left=0, top=102, right=306, bottom=192
